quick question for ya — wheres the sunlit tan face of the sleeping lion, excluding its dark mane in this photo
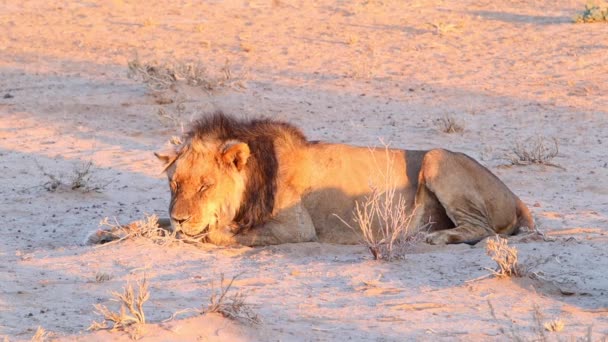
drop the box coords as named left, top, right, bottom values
left=156, top=141, right=250, bottom=235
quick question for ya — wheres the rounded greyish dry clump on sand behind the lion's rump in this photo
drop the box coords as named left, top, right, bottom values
left=509, top=136, right=559, bottom=167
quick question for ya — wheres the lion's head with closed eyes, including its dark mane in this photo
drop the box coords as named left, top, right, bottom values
left=156, top=113, right=292, bottom=235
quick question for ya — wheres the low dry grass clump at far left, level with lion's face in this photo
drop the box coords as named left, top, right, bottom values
left=36, top=160, right=112, bottom=193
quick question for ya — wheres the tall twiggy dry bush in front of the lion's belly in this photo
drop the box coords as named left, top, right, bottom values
left=336, top=145, right=428, bottom=261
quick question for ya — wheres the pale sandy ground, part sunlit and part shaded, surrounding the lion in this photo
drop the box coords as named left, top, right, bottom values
left=0, top=0, right=608, bottom=341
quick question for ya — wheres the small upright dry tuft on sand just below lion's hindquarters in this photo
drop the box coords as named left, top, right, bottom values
left=486, top=235, right=527, bottom=278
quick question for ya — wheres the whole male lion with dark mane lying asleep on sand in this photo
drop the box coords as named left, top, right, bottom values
left=156, top=113, right=534, bottom=246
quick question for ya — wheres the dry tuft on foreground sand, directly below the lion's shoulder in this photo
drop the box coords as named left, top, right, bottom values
left=203, top=273, right=261, bottom=324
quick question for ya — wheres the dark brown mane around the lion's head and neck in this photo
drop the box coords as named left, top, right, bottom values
left=186, top=111, right=307, bottom=231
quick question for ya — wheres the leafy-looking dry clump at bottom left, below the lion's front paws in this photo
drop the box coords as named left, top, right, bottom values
left=89, top=276, right=150, bottom=339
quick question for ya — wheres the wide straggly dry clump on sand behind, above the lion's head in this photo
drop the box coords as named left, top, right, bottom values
left=128, top=57, right=245, bottom=92
